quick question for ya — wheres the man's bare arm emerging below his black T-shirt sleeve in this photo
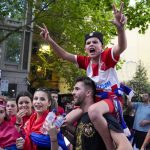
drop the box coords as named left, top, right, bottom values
left=110, top=130, right=133, bottom=150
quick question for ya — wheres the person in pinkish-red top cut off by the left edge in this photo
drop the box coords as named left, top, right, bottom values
left=0, top=96, right=20, bottom=150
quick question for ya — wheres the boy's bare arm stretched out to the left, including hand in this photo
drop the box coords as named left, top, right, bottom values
left=36, top=24, right=76, bottom=63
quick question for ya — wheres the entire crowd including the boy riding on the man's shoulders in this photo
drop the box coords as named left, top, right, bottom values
left=0, top=3, right=150, bottom=150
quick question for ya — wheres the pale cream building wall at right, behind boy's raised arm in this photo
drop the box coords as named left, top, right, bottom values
left=113, top=26, right=150, bottom=81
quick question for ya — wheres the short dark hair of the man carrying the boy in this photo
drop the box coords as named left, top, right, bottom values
left=75, top=76, right=96, bottom=99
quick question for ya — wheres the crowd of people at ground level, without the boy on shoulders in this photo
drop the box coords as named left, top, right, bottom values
left=0, top=77, right=150, bottom=150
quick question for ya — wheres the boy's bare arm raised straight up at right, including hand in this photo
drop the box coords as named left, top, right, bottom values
left=111, top=2, right=127, bottom=56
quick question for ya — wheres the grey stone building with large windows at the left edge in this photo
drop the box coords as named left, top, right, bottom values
left=0, top=6, right=32, bottom=97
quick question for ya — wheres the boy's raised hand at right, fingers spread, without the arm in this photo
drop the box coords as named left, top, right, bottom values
left=111, top=2, right=127, bottom=29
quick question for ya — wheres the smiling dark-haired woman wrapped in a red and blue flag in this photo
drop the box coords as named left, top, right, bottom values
left=16, top=88, right=67, bottom=150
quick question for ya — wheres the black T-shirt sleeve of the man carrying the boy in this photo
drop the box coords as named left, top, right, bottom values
left=104, top=114, right=123, bottom=133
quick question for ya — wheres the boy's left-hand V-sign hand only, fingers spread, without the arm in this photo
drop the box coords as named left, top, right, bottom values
left=36, top=23, right=50, bottom=41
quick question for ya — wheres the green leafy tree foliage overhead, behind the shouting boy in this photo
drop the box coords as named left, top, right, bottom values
left=0, top=0, right=150, bottom=90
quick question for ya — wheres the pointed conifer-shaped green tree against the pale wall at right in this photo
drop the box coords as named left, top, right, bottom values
left=127, top=61, right=150, bottom=98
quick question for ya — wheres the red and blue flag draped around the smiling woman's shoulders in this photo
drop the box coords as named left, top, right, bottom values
left=23, top=111, right=67, bottom=150
